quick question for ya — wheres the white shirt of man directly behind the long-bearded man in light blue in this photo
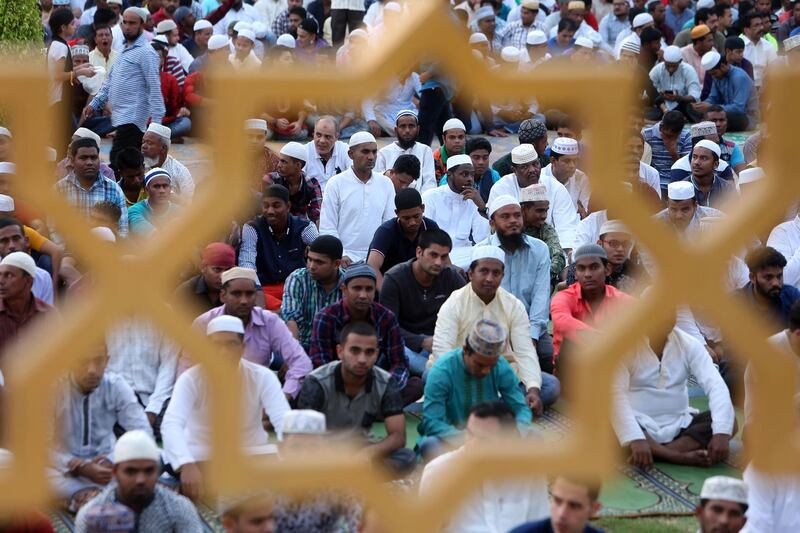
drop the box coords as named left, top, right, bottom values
left=487, top=174, right=580, bottom=249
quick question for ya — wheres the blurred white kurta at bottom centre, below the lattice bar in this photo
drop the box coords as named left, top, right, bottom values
left=419, top=448, right=550, bottom=533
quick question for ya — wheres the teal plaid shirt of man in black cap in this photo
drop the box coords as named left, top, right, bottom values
left=281, top=268, right=344, bottom=352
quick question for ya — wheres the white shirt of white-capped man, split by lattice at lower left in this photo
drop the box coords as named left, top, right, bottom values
left=161, top=360, right=290, bottom=470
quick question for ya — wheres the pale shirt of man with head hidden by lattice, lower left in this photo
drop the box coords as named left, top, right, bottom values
left=106, top=318, right=178, bottom=415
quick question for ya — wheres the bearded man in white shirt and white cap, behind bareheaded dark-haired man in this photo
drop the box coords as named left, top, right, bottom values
left=375, top=109, right=437, bottom=193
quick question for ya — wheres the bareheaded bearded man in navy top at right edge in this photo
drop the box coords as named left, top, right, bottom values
left=739, top=246, right=800, bottom=333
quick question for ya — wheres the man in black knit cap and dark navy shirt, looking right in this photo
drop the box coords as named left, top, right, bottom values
left=367, top=189, right=439, bottom=284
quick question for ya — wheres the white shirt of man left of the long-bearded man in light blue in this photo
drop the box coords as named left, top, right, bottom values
left=422, top=184, right=496, bottom=250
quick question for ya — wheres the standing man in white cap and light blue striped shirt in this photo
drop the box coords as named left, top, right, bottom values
left=83, top=7, right=164, bottom=176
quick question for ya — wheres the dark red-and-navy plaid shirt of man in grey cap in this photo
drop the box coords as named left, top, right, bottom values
left=309, top=300, right=408, bottom=388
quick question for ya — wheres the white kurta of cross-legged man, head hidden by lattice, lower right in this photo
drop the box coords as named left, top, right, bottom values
left=612, top=328, right=735, bottom=446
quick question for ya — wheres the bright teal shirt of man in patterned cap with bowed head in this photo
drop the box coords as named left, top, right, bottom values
left=418, top=348, right=533, bottom=440
